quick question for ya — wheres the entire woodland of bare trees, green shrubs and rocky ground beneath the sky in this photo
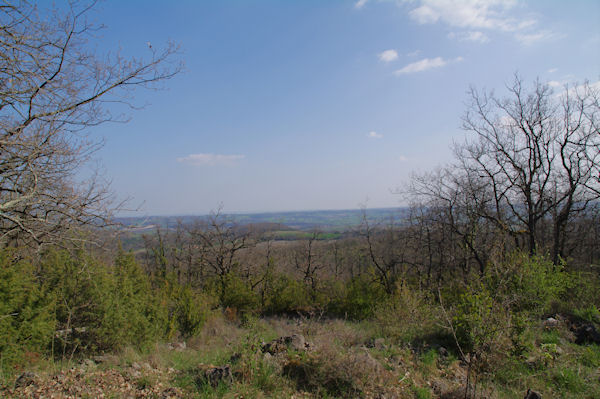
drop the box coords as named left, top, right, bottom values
left=0, top=2, right=600, bottom=399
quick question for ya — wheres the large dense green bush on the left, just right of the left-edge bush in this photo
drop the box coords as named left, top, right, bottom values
left=40, top=249, right=165, bottom=357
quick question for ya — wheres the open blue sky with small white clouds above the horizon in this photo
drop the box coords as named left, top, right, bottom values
left=82, top=0, right=600, bottom=215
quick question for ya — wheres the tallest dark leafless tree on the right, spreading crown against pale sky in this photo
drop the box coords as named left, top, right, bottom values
left=456, top=76, right=600, bottom=262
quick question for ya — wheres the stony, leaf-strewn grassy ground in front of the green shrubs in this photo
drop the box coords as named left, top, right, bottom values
left=0, top=318, right=600, bottom=399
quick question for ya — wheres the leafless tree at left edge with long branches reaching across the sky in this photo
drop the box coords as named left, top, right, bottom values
left=0, top=0, right=181, bottom=245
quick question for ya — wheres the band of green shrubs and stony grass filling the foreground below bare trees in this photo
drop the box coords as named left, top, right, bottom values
left=0, top=243, right=600, bottom=398
